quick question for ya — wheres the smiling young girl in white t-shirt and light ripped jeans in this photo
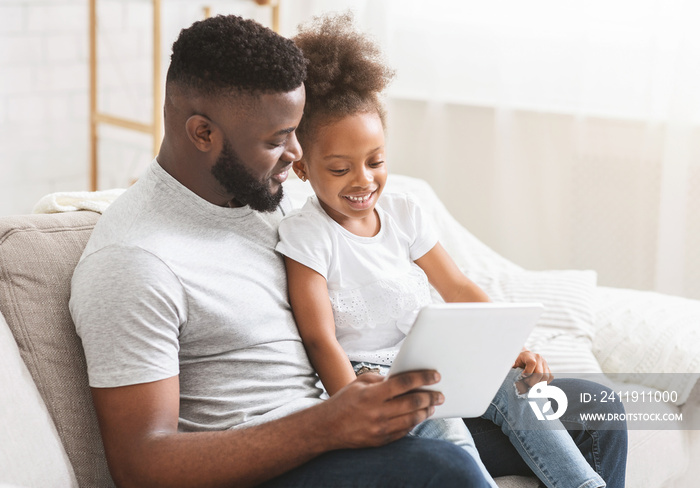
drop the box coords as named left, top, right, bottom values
left=277, top=15, right=605, bottom=488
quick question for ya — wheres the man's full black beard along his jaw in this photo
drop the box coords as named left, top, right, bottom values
left=211, top=140, right=283, bottom=212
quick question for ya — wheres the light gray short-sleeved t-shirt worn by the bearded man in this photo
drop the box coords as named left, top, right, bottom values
left=70, top=161, right=321, bottom=431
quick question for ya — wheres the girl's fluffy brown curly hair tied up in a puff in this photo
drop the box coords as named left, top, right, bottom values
left=293, top=13, right=394, bottom=145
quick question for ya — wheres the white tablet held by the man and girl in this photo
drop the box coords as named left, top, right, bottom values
left=389, top=303, right=544, bottom=418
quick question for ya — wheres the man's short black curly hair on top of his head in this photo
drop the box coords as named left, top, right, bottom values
left=167, top=15, right=306, bottom=96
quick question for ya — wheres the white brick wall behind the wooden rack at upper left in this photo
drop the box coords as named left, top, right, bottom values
left=0, top=0, right=271, bottom=215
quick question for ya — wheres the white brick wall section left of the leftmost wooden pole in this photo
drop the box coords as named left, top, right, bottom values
left=0, top=0, right=88, bottom=215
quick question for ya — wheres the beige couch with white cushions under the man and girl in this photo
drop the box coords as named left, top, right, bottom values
left=0, top=175, right=700, bottom=488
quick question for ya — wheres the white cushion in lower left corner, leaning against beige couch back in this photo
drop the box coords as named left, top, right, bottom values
left=0, top=308, right=78, bottom=487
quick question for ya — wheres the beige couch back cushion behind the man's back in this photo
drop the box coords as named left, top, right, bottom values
left=0, top=212, right=113, bottom=487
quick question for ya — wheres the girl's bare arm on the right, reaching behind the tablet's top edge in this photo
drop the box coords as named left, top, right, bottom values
left=415, top=242, right=490, bottom=302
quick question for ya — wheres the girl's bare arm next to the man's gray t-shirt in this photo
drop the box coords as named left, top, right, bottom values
left=284, top=256, right=356, bottom=395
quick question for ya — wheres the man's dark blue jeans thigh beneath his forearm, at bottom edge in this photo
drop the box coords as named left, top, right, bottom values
left=261, top=437, right=490, bottom=488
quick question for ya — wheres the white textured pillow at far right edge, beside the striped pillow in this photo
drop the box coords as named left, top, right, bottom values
left=593, top=287, right=700, bottom=405
